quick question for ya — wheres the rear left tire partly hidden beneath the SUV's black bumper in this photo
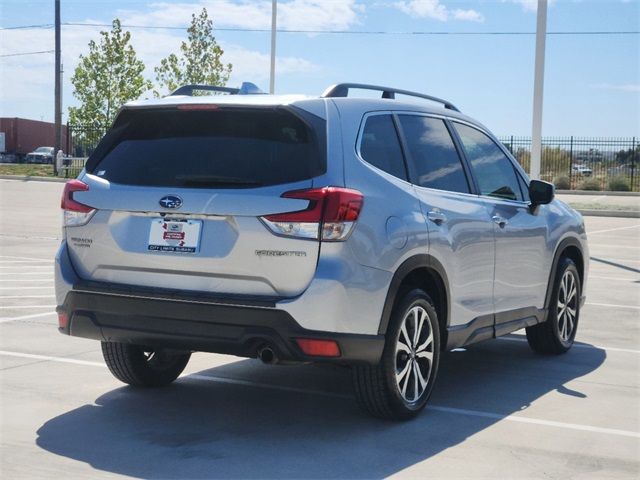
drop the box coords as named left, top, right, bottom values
left=102, top=342, right=191, bottom=387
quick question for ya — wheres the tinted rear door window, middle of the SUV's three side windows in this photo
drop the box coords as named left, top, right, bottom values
left=399, top=115, right=469, bottom=193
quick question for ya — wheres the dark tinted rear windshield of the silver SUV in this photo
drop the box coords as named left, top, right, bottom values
left=87, top=107, right=326, bottom=188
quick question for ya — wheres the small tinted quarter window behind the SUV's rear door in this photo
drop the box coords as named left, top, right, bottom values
left=360, top=115, right=407, bottom=180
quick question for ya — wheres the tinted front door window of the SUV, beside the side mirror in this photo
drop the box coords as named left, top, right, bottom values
left=455, top=123, right=522, bottom=200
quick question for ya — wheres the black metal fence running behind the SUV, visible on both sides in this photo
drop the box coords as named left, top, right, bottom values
left=65, top=125, right=640, bottom=191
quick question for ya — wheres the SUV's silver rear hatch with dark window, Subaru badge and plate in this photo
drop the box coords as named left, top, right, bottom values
left=65, top=104, right=326, bottom=297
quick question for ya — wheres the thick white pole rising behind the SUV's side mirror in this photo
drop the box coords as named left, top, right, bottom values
left=529, top=0, right=547, bottom=180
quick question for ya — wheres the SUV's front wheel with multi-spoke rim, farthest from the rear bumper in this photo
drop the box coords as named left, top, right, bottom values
left=527, top=257, right=582, bottom=354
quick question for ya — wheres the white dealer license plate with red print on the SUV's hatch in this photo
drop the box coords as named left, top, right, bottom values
left=148, top=218, right=202, bottom=253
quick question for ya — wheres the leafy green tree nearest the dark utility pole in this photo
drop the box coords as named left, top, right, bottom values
left=69, top=18, right=153, bottom=125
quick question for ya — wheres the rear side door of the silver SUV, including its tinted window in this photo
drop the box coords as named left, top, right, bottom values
left=398, top=113, right=495, bottom=336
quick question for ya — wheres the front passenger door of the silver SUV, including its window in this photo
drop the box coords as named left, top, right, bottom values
left=454, top=122, right=549, bottom=335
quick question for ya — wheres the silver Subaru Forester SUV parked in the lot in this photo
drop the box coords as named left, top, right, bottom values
left=55, top=84, right=589, bottom=419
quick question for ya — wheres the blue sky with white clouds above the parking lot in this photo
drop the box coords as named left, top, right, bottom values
left=0, top=0, right=640, bottom=137
